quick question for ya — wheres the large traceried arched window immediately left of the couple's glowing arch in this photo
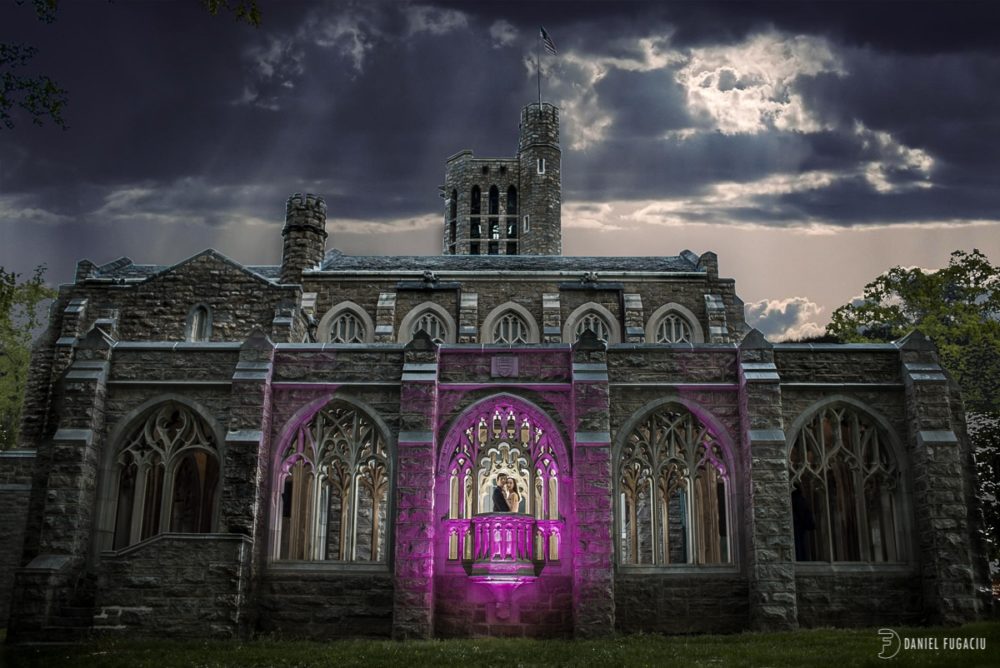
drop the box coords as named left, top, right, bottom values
left=271, top=400, right=392, bottom=563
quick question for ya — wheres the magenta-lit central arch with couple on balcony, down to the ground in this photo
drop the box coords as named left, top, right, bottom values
left=434, top=394, right=572, bottom=636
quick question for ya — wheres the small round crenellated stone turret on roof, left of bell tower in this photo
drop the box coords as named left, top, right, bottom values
left=281, top=193, right=327, bottom=283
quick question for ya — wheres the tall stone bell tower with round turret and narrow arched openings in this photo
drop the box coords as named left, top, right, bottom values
left=441, top=103, right=562, bottom=255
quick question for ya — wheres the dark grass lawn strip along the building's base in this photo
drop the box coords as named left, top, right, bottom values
left=0, top=621, right=1000, bottom=668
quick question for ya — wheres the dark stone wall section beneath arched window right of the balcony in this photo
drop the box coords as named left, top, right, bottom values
left=615, top=570, right=750, bottom=634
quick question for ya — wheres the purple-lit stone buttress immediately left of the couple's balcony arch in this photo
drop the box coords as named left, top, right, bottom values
left=392, top=331, right=438, bottom=639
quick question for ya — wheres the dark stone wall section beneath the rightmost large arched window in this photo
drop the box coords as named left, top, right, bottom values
left=795, top=564, right=926, bottom=628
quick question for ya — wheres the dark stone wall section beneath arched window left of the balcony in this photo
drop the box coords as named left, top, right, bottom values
left=257, top=563, right=393, bottom=640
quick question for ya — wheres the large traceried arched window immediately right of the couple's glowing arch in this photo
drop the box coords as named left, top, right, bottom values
left=616, top=404, right=732, bottom=565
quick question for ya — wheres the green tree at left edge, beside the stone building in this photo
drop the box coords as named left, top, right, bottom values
left=0, top=266, right=56, bottom=450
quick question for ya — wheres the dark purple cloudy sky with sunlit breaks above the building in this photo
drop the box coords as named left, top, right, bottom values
left=0, top=0, right=1000, bottom=338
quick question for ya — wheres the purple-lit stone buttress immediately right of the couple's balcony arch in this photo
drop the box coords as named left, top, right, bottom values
left=572, top=330, right=615, bottom=638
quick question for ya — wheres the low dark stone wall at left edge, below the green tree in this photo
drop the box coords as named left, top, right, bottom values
left=0, top=450, right=35, bottom=627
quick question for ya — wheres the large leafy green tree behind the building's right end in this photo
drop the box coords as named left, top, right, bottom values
left=827, top=250, right=1000, bottom=580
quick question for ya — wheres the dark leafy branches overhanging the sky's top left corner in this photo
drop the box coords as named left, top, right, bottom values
left=0, top=0, right=260, bottom=129
